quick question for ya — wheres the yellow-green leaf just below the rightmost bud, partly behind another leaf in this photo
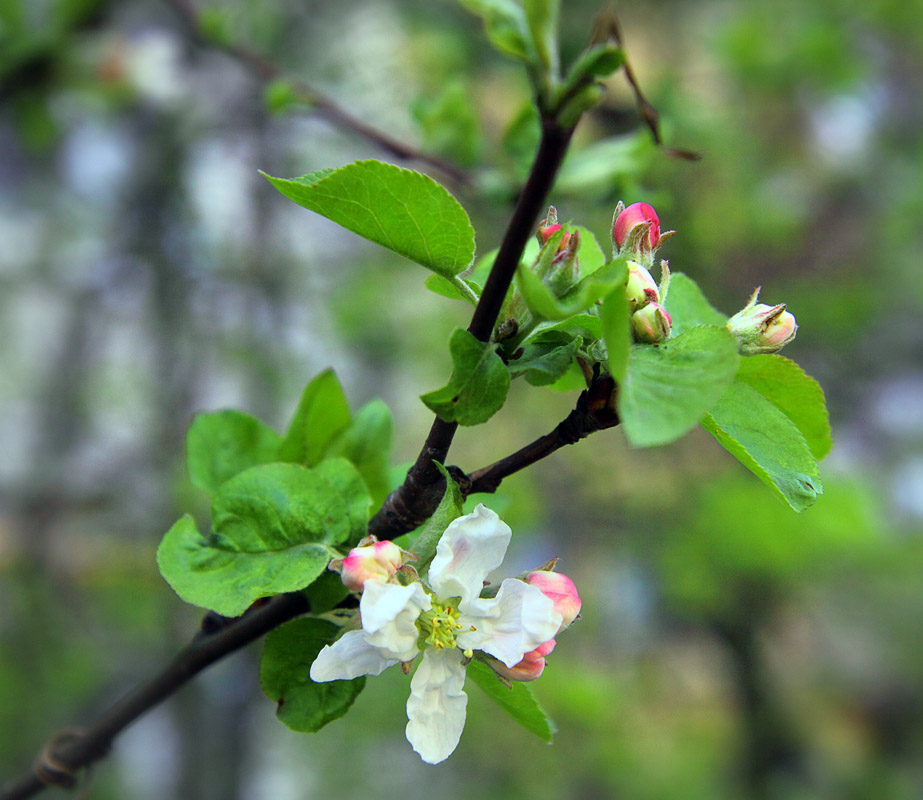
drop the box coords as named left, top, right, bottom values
left=737, top=354, right=833, bottom=461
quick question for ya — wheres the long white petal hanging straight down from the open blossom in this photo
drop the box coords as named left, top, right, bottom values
left=407, top=648, right=468, bottom=764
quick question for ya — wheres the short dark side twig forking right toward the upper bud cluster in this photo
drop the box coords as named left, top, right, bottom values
left=459, top=375, right=619, bottom=497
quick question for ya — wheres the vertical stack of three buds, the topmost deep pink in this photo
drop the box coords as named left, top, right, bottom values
left=612, top=202, right=675, bottom=344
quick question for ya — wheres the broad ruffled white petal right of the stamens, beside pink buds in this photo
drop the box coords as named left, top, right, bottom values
left=456, top=578, right=561, bottom=667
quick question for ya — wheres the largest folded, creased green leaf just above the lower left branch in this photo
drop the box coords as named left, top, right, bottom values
left=157, top=464, right=350, bottom=617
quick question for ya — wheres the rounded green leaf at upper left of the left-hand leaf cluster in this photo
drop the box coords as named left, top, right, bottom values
left=186, top=411, right=282, bottom=494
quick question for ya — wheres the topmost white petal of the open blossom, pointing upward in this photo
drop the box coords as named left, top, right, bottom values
left=429, top=504, right=513, bottom=611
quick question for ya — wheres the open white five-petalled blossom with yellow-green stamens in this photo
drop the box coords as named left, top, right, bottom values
left=311, top=505, right=562, bottom=764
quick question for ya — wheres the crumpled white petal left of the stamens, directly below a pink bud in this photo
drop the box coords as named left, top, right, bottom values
left=359, top=581, right=432, bottom=661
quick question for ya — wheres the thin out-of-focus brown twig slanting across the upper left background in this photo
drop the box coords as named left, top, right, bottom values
left=166, top=0, right=470, bottom=185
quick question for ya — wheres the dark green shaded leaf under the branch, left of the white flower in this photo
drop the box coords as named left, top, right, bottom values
left=260, top=617, right=365, bottom=733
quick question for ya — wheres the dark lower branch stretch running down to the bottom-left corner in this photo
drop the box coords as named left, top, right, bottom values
left=0, top=593, right=310, bottom=800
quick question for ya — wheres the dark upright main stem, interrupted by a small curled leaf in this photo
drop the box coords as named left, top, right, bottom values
left=369, top=117, right=574, bottom=539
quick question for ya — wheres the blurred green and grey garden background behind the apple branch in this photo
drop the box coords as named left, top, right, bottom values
left=0, top=0, right=923, bottom=800
